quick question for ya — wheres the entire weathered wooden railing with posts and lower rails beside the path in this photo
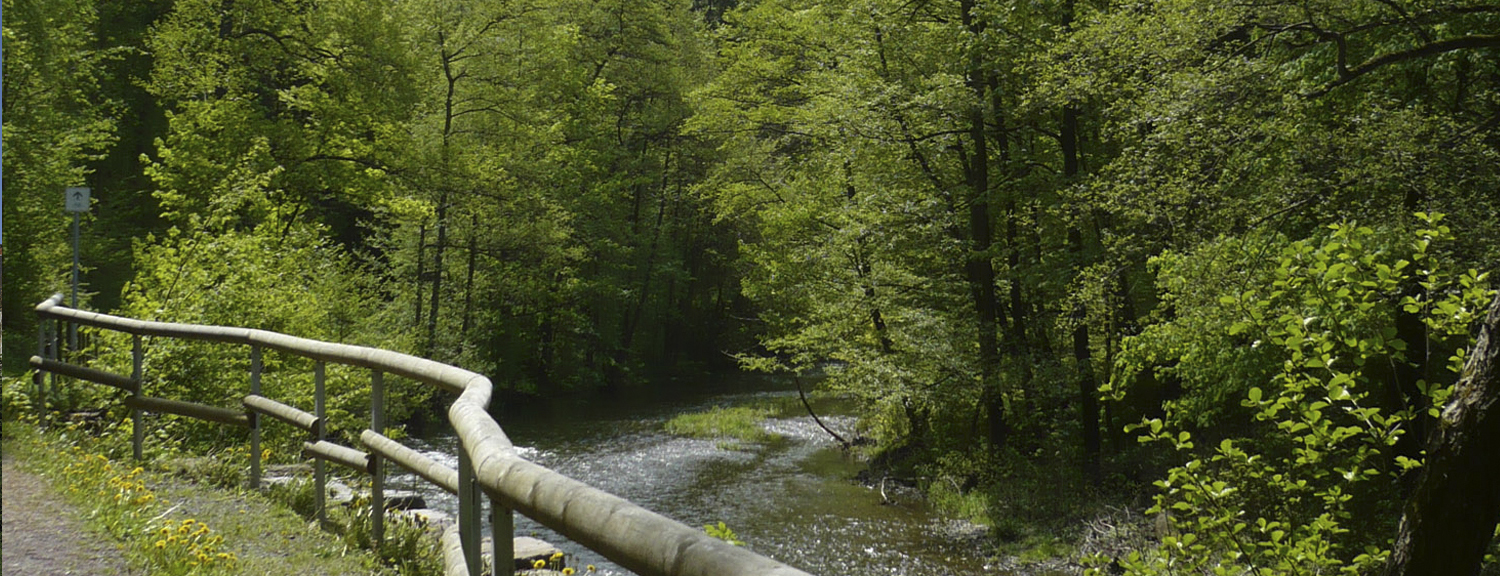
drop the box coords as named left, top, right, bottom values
left=32, top=294, right=806, bottom=576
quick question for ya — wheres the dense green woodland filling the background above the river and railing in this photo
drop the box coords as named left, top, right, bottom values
left=3, top=0, right=1500, bottom=575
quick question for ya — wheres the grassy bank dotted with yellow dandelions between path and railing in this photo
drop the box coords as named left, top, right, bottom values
left=3, top=422, right=441, bottom=576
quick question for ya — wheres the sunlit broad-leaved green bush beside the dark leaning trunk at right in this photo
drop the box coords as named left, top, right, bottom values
left=1098, top=215, right=1491, bottom=575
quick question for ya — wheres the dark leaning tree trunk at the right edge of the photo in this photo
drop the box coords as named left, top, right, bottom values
left=1386, top=296, right=1500, bottom=576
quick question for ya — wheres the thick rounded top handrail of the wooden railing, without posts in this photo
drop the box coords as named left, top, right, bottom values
left=36, top=294, right=807, bottom=576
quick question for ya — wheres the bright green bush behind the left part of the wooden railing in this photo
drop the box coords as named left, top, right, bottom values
left=98, top=225, right=435, bottom=453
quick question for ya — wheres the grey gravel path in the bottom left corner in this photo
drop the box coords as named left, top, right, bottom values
left=0, top=455, right=132, bottom=576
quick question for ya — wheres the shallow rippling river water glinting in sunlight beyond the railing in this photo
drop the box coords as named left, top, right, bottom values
left=392, top=377, right=990, bottom=576
